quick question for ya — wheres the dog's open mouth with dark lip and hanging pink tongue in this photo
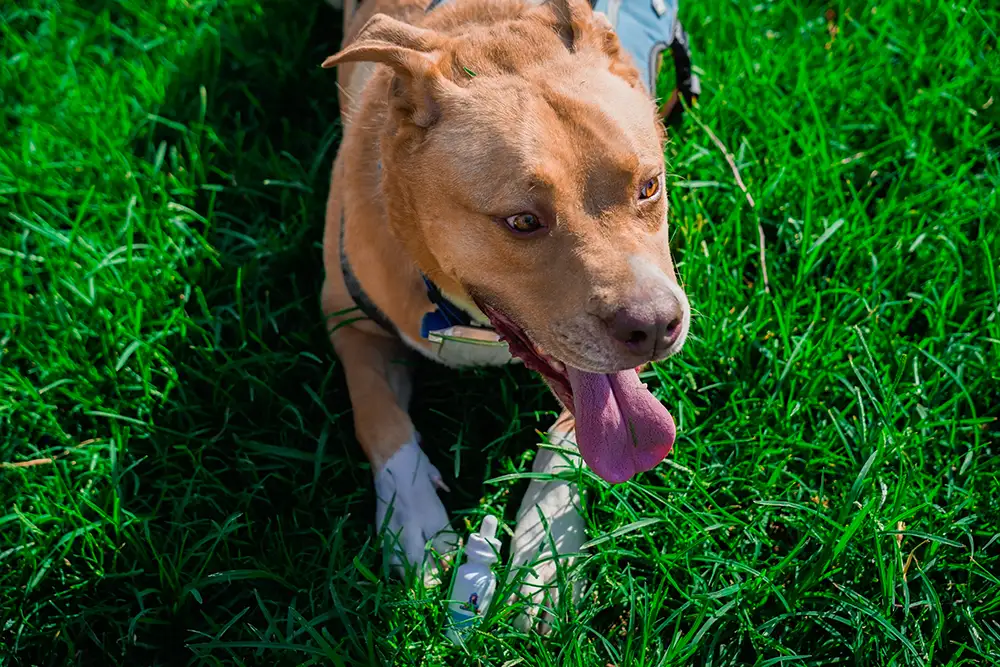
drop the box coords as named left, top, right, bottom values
left=477, top=303, right=675, bottom=484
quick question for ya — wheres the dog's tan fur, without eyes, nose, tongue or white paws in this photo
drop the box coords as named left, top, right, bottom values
left=323, top=0, right=687, bottom=480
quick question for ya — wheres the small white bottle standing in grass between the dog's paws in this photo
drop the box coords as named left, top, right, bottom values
left=445, top=514, right=500, bottom=644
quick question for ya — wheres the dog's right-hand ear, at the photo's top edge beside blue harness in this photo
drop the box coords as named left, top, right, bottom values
left=548, top=0, right=642, bottom=88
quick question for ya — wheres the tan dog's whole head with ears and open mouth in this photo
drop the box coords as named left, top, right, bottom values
left=324, top=0, right=689, bottom=481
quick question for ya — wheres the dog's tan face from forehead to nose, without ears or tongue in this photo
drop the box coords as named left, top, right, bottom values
left=412, top=58, right=689, bottom=373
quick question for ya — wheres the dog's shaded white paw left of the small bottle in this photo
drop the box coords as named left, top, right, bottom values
left=375, top=442, right=458, bottom=586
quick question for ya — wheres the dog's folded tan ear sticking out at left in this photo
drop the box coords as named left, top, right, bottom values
left=323, top=14, right=461, bottom=128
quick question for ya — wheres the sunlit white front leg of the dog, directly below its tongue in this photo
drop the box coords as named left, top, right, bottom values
left=510, top=432, right=586, bottom=634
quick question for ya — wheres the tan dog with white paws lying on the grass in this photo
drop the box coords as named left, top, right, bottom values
left=321, top=0, right=690, bottom=626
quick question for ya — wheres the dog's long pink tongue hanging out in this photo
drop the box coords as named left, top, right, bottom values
left=567, top=367, right=675, bottom=484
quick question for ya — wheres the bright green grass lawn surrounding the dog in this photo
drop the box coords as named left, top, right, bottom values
left=0, top=0, right=1000, bottom=667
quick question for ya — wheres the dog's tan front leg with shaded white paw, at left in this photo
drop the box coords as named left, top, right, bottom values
left=332, top=326, right=457, bottom=584
